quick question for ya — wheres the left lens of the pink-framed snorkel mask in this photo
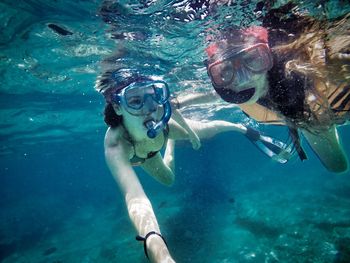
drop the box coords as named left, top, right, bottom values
left=210, top=60, right=234, bottom=86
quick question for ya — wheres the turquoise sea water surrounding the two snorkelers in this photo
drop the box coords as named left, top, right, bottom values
left=0, top=0, right=350, bottom=263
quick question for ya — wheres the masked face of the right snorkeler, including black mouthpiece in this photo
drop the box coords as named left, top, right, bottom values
left=207, top=43, right=273, bottom=104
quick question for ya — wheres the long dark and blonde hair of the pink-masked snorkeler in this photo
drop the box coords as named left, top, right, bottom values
left=263, top=5, right=350, bottom=129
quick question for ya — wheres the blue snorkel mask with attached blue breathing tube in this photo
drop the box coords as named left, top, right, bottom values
left=114, top=80, right=171, bottom=138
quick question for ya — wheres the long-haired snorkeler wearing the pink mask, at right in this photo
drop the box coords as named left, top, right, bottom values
left=177, top=10, right=350, bottom=173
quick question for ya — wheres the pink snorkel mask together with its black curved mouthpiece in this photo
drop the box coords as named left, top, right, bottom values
left=206, top=26, right=273, bottom=104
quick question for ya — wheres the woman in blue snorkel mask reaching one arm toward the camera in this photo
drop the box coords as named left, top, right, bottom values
left=95, top=69, right=292, bottom=262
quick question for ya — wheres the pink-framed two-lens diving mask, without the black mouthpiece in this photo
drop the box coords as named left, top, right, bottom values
left=208, top=43, right=273, bottom=88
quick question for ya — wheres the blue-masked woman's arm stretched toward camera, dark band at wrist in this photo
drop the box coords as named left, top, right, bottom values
left=104, top=129, right=174, bottom=263
